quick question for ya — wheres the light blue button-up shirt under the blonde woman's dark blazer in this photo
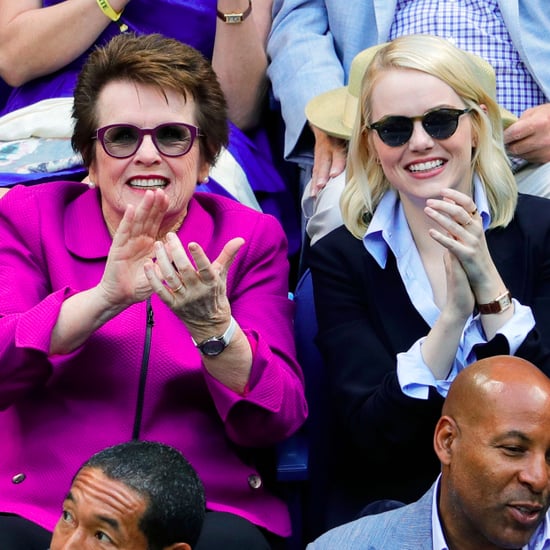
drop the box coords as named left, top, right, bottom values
left=363, top=176, right=535, bottom=399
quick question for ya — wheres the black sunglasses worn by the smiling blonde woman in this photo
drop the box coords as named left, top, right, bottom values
left=367, top=108, right=471, bottom=147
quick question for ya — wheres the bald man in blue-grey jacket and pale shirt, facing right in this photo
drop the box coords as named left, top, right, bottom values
left=308, top=355, right=550, bottom=550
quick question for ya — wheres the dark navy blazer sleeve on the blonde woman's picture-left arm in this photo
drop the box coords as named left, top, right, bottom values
left=310, top=227, right=443, bottom=462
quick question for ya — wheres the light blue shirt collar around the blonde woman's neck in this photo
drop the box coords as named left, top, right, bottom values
left=363, top=174, right=491, bottom=269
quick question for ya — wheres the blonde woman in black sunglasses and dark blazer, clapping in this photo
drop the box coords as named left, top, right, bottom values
left=310, top=35, right=550, bottom=532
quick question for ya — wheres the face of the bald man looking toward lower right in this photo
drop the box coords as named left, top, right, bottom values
left=442, top=380, right=550, bottom=549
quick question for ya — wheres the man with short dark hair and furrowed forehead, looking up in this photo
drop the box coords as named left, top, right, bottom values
left=51, top=441, right=205, bottom=550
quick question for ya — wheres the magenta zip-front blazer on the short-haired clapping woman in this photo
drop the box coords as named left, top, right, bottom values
left=0, top=182, right=307, bottom=536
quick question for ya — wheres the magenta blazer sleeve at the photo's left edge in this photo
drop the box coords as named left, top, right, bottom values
left=0, top=188, right=74, bottom=409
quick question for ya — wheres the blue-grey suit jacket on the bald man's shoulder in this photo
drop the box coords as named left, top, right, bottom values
left=307, top=483, right=436, bottom=550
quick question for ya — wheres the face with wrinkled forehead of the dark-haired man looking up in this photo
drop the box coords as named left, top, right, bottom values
left=50, top=468, right=148, bottom=550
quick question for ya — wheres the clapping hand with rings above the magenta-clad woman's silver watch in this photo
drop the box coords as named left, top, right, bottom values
left=145, top=233, right=244, bottom=341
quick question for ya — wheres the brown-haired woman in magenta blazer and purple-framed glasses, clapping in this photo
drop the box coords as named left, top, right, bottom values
left=0, top=35, right=306, bottom=548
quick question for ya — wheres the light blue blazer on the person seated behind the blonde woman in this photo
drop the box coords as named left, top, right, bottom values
left=267, top=0, right=550, bottom=163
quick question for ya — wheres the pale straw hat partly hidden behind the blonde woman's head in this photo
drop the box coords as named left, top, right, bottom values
left=306, top=42, right=517, bottom=139
